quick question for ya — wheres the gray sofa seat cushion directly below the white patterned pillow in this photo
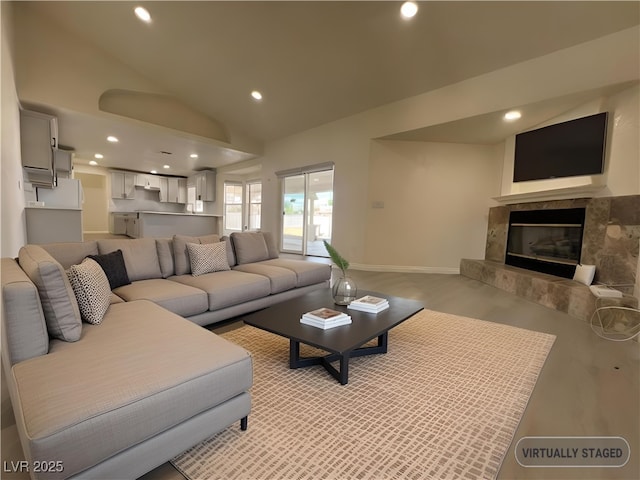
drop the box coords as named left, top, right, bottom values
left=169, top=270, right=271, bottom=310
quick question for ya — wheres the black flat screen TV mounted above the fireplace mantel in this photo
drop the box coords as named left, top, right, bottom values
left=513, top=112, right=607, bottom=182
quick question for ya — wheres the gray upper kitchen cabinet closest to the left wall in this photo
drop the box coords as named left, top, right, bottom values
left=20, top=110, right=58, bottom=188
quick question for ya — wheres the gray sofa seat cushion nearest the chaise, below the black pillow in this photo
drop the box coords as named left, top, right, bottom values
left=114, top=278, right=209, bottom=317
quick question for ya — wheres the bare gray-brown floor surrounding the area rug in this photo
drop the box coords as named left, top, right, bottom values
left=2, top=272, right=640, bottom=480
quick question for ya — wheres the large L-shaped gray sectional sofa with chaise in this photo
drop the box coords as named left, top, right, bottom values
left=1, top=233, right=331, bottom=478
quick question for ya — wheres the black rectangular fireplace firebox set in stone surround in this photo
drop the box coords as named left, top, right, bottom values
left=505, top=208, right=585, bottom=278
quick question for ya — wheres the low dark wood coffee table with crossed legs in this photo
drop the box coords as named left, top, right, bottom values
left=243, top=289, right=424, bottom=385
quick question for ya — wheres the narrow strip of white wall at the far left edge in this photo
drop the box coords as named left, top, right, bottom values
left=0, top=2, right=27, bottom=257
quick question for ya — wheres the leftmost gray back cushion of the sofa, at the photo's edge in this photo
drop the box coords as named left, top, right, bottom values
left=0, top=258, right=49, bottom=365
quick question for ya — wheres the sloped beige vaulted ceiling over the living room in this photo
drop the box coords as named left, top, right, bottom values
left=14, top=1, right=640, bottom=174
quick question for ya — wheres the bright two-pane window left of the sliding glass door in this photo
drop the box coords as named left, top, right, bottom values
left=224, top=181, right=262, bottom=234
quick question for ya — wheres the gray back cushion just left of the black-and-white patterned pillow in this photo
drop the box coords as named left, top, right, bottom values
left=18, top=245, right=82, bottom=342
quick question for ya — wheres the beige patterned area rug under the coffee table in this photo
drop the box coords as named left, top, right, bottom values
left=172, top=310, right=555, bottom=480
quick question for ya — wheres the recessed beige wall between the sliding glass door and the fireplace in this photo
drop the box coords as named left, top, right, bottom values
left=364, top=141, right=503, bottom=273
